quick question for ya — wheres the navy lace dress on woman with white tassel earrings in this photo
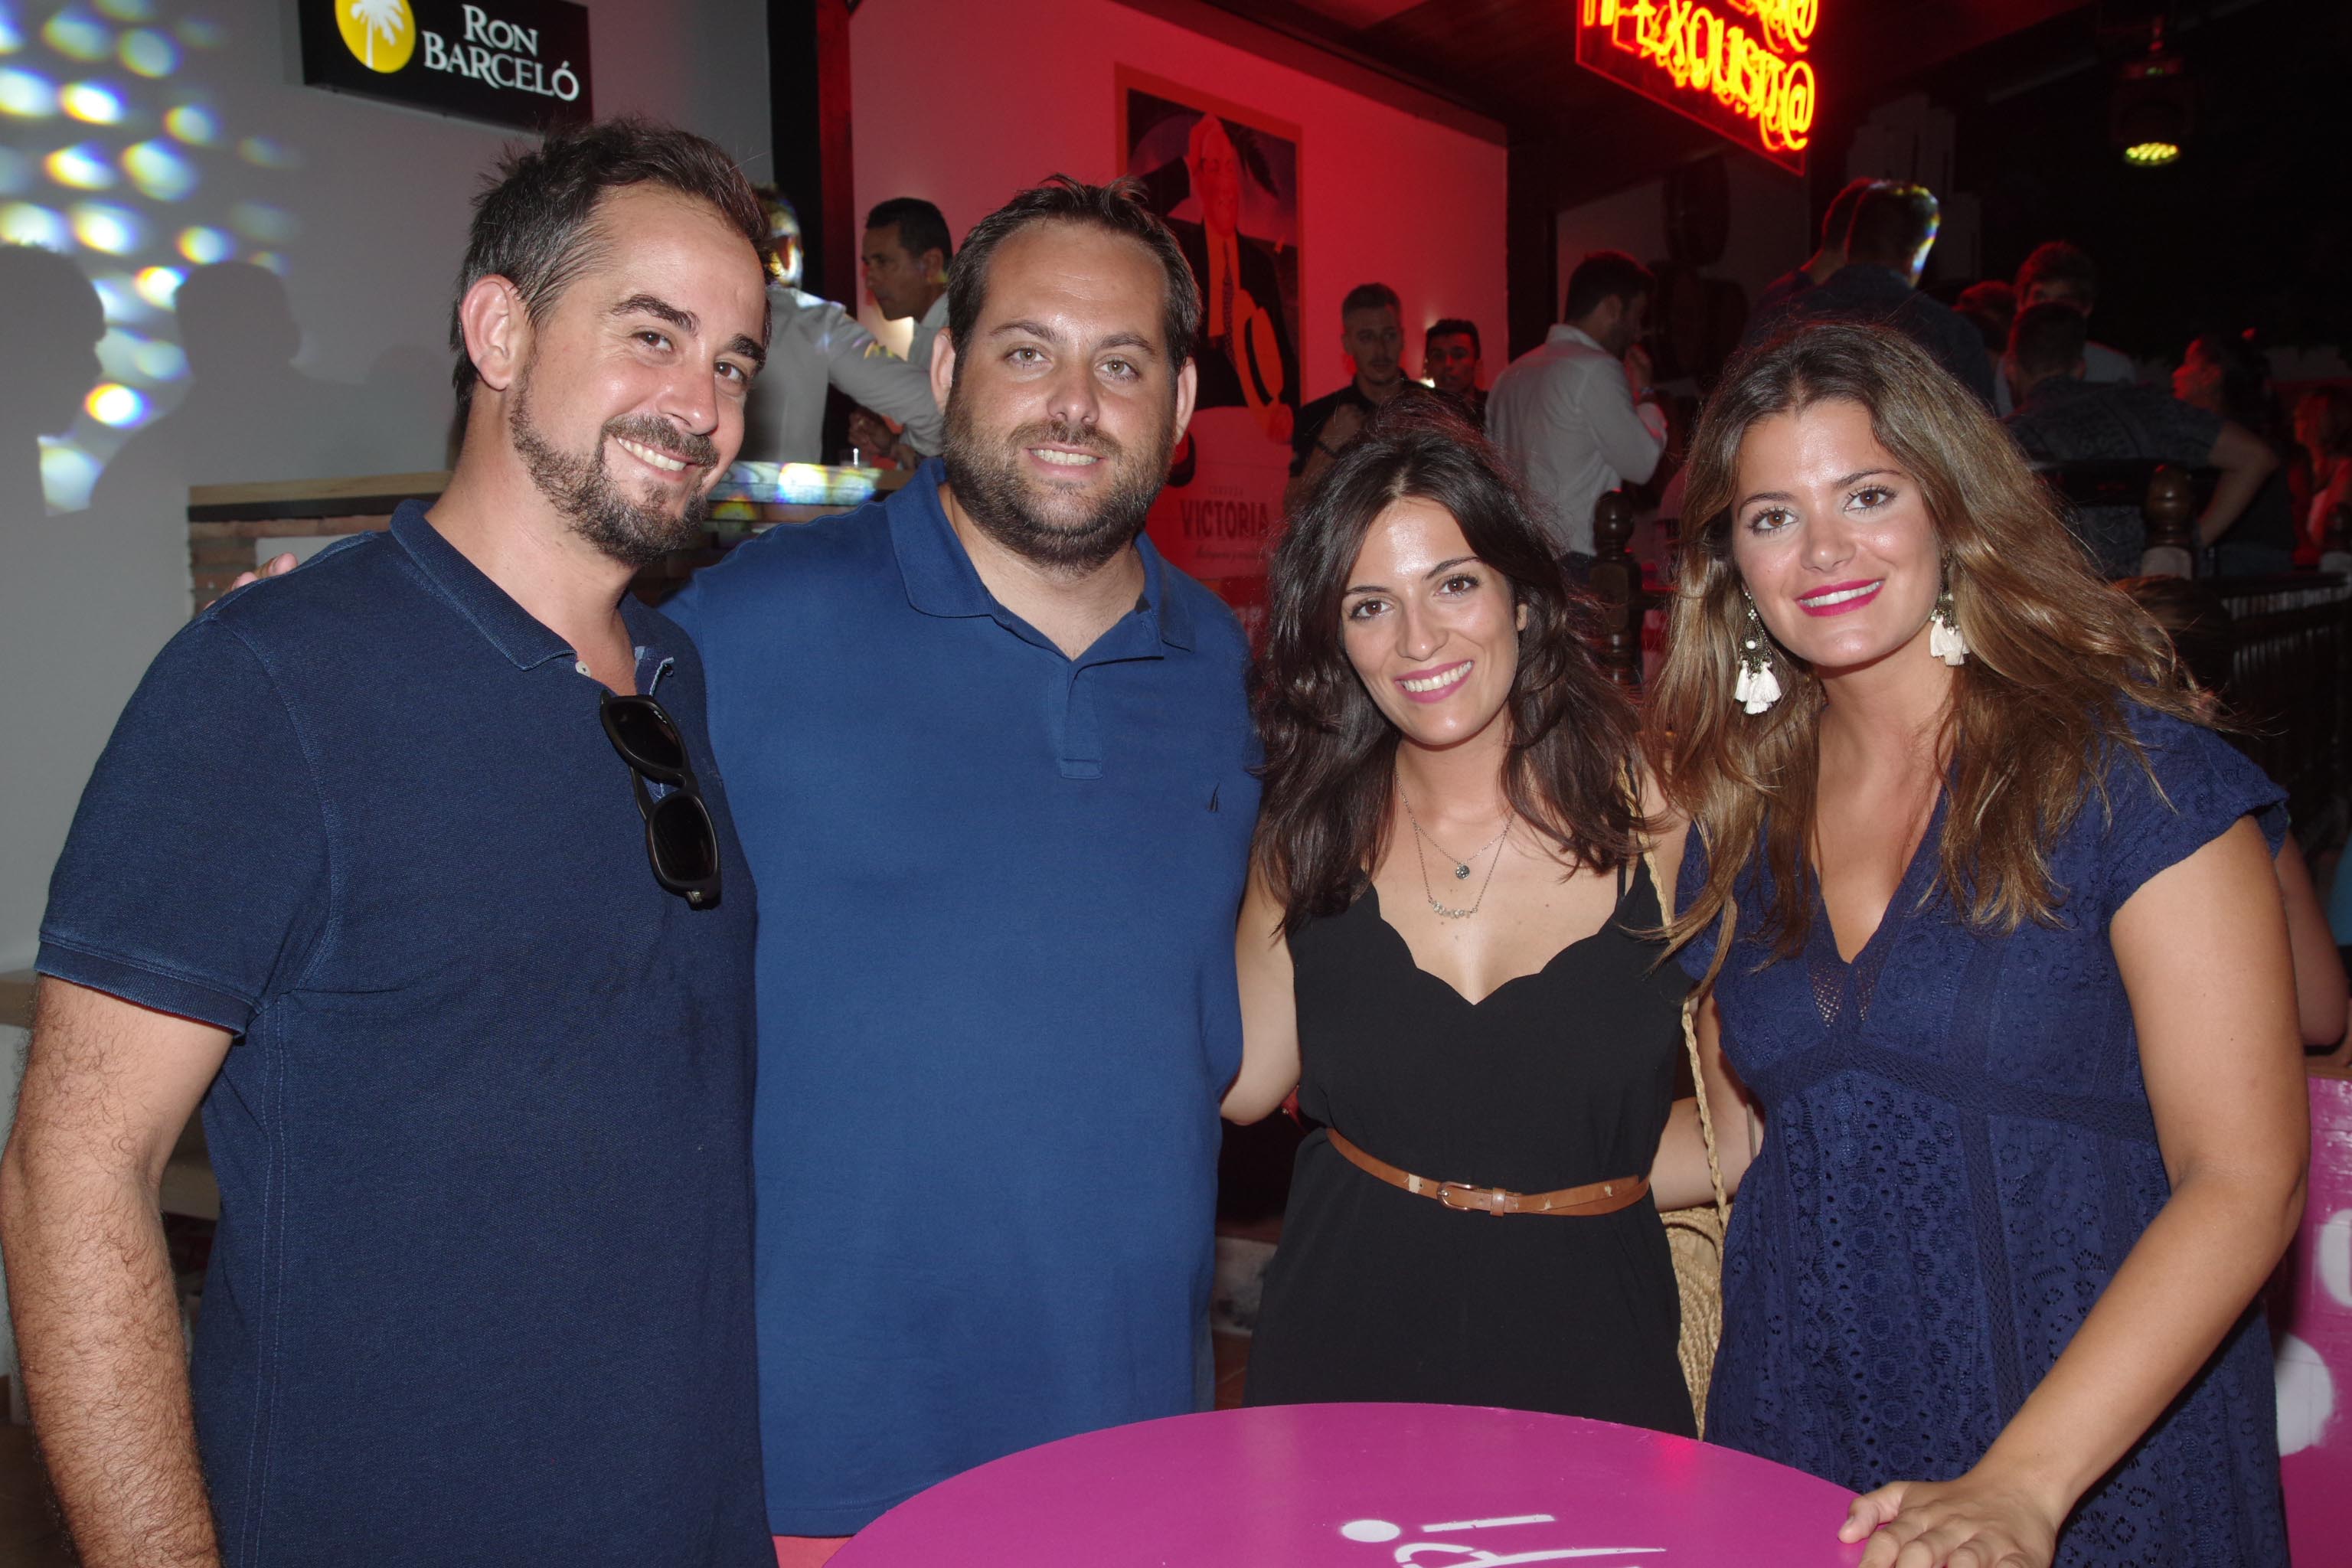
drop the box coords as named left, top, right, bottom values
left=1679, top=712, right=2286, bottom=1568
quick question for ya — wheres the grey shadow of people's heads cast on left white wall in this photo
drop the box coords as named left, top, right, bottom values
left=0, top=247, right=449, bottom=969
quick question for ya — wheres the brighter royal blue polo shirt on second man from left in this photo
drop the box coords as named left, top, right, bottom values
left=668, top=463, right=1259, bottom=1535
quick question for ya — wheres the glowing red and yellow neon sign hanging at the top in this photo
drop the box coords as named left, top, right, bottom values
left=1576, top=0, right=1821, bottom=174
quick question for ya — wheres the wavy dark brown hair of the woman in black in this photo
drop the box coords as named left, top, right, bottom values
left=1251, top=397, right=1651, bottom=931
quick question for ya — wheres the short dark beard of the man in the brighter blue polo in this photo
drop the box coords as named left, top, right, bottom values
left=939, top=390, right=1176, bottom=576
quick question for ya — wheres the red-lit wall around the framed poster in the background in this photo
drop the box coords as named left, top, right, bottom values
left=849, top=0, right=1505, bottom=397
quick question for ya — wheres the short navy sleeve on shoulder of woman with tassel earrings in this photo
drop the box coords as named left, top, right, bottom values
left=2084, top=710, right=2286, bottom=920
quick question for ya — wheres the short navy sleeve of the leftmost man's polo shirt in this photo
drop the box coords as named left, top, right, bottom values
left=38, top=616, right=329, bottom=1034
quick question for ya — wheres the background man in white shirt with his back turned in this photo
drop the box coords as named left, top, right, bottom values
left=1487, top=252, right=1665, bottom=567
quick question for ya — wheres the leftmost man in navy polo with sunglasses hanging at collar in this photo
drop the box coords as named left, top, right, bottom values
left=0, top=122, right=774, bottom=1568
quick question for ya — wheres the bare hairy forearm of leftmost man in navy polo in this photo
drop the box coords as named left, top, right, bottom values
left=0, top=1145, right=221, bottom=1568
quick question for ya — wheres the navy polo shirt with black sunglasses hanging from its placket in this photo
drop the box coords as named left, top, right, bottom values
left=40, top=503, right=774, bottom=1568
